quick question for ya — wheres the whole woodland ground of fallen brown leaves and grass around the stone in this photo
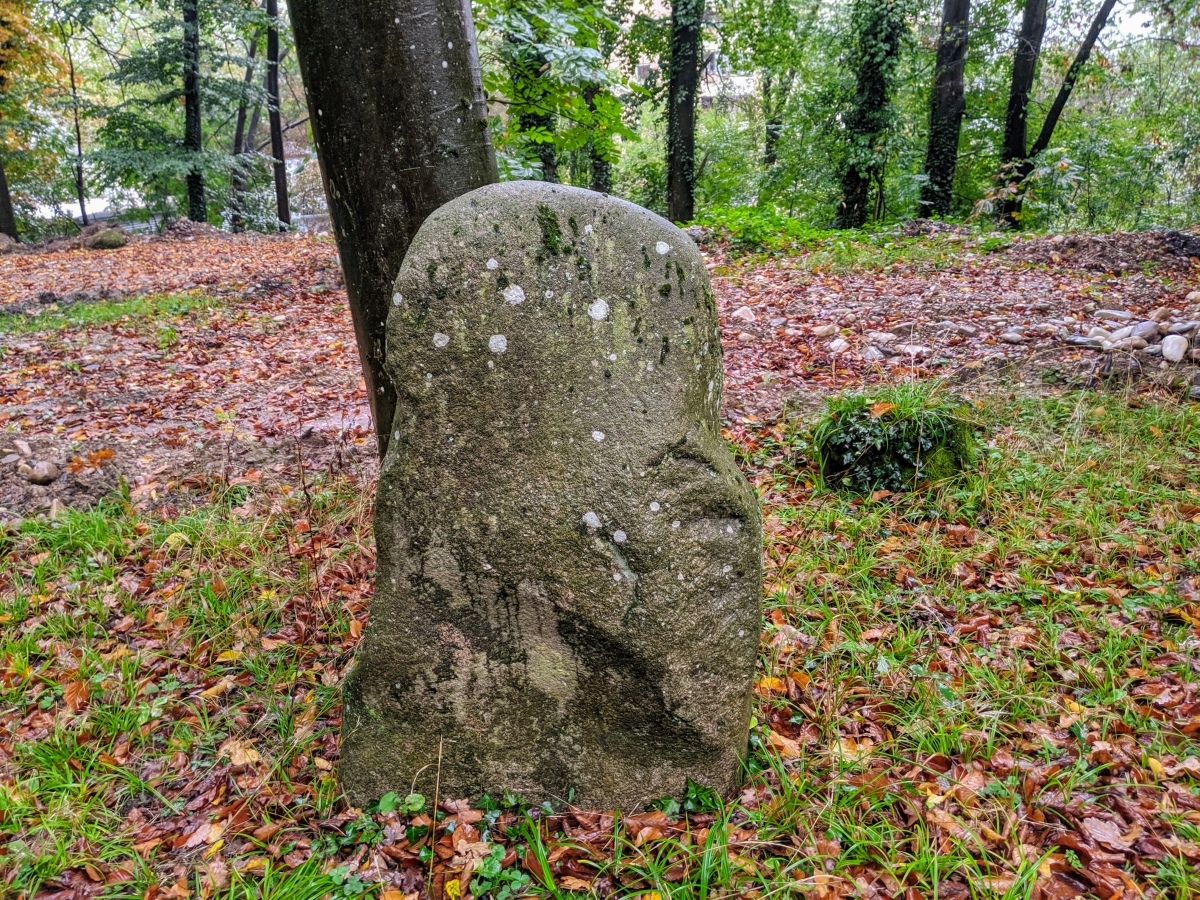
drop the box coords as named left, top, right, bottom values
left=0, top=229, right=1200, bottom=900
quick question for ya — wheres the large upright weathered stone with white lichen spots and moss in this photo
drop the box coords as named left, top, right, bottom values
left=342, top=182, right=762, bottom=810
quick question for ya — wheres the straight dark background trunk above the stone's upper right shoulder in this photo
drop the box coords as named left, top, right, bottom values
left=667, top=0, right=704, bottom=222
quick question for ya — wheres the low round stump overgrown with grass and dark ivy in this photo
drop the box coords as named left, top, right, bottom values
left=812, top=383, right=977, bottom=493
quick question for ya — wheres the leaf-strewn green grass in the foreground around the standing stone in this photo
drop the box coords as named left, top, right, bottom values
left=0, top=394, right=1200, bottom=900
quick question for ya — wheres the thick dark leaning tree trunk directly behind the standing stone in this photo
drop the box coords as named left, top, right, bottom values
left=289, top=0, right=497, bottom=452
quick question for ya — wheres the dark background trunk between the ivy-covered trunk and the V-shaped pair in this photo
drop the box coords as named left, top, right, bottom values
left=920, top=0, right=971, bottom=216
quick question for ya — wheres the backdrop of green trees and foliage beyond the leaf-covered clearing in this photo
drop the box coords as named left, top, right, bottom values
left=0, top=0, right=1200, bottom=244
